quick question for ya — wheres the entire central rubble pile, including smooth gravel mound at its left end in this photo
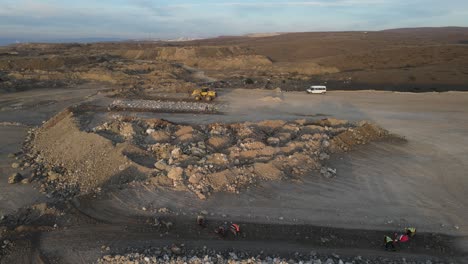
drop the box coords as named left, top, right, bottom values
left=16, top=106, right=389, bottom=199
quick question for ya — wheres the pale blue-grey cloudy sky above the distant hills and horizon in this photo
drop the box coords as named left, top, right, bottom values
left=0, top=0, right=468, bottom=39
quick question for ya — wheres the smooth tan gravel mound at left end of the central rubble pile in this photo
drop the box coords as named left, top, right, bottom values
left=28, top=110, right=147, bottom=193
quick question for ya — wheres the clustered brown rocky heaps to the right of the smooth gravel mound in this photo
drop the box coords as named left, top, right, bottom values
left=89, top=116, right=388, bottom=199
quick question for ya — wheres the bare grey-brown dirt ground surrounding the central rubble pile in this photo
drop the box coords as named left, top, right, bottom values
left=0, top=86, right=468, bottom=263
